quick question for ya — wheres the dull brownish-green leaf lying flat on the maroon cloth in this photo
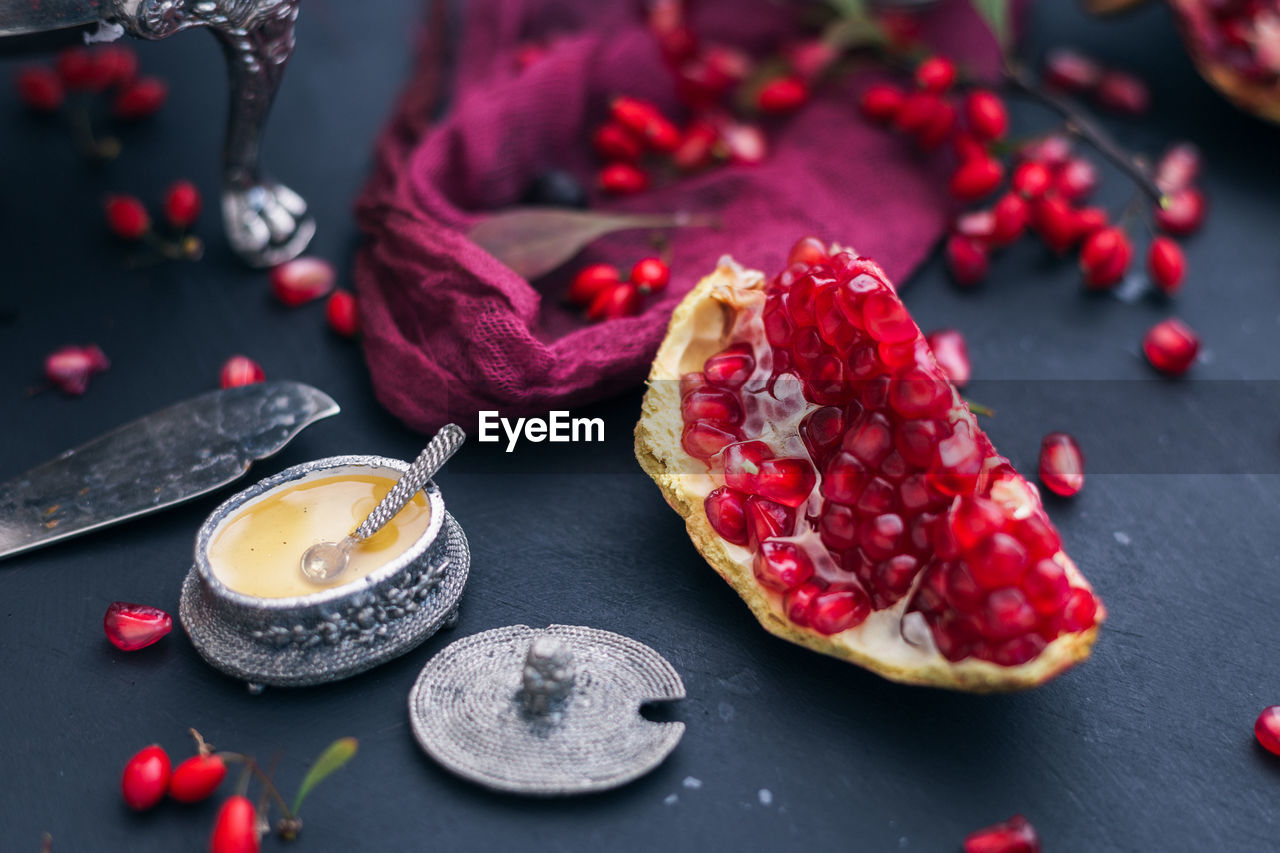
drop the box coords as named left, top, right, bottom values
left=468, top=207, right=717, bottom=280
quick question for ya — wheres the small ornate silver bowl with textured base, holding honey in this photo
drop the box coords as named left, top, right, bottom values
left=178, top=456, right=471, bottom=686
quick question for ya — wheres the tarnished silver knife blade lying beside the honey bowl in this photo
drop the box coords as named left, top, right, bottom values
left=0, top=382, right=339, bottom=560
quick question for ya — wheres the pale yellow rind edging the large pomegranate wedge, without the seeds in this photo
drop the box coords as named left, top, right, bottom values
left=635, top=256, right=1106, bottom=693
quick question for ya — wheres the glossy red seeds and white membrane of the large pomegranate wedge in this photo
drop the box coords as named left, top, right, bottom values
left=681, top=241, right=1098, bottom=666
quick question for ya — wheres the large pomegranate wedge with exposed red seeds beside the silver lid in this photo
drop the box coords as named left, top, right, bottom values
left=636, top=242, right=1105, bottom=692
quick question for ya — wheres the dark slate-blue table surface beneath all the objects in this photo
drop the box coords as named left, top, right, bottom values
left=0, top=0, right=1280, bottom=853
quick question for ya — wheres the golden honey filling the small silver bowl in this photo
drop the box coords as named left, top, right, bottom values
left=209, top=473, right=431, bottom=598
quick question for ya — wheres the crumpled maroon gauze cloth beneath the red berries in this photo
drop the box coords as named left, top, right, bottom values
left=355, top=0, right=998, bottom=432
